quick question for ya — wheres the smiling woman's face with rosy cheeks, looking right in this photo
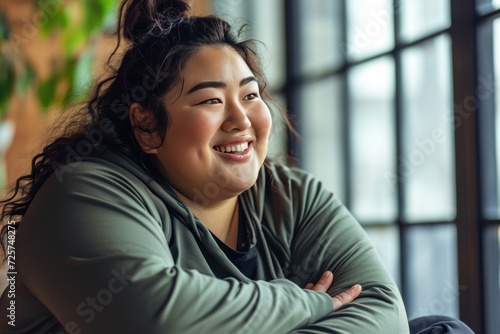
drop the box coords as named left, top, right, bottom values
left=156, top=46, right=271, bottom=205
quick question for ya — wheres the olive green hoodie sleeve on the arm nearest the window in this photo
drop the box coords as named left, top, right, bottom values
left=275, top=170, right=409, bottom=334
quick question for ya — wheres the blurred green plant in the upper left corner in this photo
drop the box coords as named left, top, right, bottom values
left=0, top=0, right=118, bottom=119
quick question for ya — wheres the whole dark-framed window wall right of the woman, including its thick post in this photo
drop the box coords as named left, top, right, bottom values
left=213, top=0, right=494, bottom=333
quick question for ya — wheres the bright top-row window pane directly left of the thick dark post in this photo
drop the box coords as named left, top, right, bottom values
left=398, top=0, right=451, bottom=41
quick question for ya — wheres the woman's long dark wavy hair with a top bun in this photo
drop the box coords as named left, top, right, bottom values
left=0, top=0, right=289, bottom=254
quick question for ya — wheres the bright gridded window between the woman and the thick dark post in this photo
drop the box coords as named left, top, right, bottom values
left=292, top=0, right=459, bottom=324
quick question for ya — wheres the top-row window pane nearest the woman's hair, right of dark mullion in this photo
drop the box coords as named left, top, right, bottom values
left=298, top=0, right=344, bottom=74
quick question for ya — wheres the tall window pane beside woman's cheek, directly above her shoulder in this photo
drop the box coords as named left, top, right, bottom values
left=299, top=77, right=345, bottom=201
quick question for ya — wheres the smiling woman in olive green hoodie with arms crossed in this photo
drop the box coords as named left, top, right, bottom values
left=0, top=0, right=452, bottom=334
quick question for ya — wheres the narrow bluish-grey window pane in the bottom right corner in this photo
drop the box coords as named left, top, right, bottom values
left=483, top=225, right=500, bottom=333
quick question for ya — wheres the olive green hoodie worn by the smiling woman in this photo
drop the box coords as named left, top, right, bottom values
left=0, top=152, right=408, bottom=334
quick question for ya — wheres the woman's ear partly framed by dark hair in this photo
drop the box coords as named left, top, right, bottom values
left=129, top=102, right=161, bottom=154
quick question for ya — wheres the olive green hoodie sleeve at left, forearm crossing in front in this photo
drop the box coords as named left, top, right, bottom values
left=16, top=163, right=333, bottom=334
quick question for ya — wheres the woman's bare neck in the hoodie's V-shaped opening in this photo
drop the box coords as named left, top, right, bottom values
left=176, top=192, right=239, bottom=249
